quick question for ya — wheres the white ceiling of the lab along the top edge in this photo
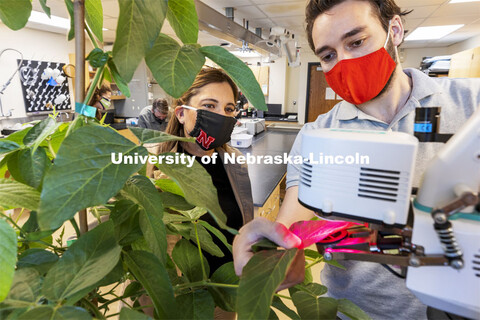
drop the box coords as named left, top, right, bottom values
left=33, top=0, right=480, bottom=48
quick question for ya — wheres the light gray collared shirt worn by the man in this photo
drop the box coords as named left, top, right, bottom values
left=287, top=69, right=480, bottom=319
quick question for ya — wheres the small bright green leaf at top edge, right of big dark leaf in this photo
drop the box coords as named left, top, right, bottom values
left=167, top=0, right=198, bottom=43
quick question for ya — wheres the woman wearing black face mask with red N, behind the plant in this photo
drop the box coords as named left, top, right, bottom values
left=155, top=68, right=253, bottom=273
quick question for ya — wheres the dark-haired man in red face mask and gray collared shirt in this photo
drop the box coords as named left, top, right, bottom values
left=233, top=0, right=480, bottom=319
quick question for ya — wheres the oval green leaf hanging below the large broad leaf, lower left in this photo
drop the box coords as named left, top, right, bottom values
left=43, top=221, right=122, bottom=300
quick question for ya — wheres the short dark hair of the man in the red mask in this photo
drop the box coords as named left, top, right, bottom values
left=305, top=0, right=412, bottom=51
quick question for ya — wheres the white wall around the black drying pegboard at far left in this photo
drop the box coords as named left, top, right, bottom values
left=0, top=23, right=79, bottom=118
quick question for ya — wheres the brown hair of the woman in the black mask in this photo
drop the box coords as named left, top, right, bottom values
left=160, top=67, right=238, bottom=152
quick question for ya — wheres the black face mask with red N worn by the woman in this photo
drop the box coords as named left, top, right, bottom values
left=182, top=106, right=237, bottom=150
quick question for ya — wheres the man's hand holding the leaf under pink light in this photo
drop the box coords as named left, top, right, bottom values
left=233, top=217, right=302, bottom=276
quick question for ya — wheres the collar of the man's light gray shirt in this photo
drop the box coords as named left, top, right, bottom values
left=337, top=68, right=442, bottom=123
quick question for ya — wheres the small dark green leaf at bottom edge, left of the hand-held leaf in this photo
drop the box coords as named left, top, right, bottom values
left=175, top=290, right=215, bottom=320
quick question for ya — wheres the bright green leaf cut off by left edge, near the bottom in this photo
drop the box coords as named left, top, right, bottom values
left=0, top=219, right=17, bottom=302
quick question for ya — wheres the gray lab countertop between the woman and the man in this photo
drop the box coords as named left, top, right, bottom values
left=233, top=128, right=298, bottom=207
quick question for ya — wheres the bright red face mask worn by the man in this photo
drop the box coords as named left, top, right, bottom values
left=325, top=26, right=396, bottom=105
